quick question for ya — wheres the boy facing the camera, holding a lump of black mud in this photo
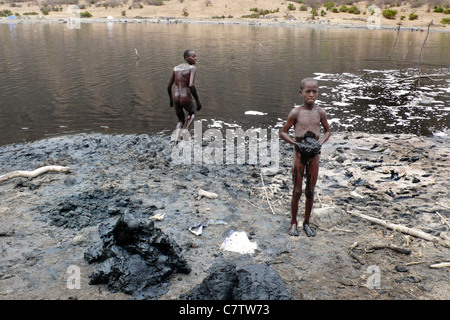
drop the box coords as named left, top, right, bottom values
left=280, top=78, right=331, bottom=237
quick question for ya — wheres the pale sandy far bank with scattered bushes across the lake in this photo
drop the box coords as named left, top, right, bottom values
left=0, top=0, right=450, bottom=33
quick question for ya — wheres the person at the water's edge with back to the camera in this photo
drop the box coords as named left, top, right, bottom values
left=167, top=50, right=202, bottom=147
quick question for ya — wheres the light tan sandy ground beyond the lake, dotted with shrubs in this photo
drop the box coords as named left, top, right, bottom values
left=0, top=0, right=448, bottom=31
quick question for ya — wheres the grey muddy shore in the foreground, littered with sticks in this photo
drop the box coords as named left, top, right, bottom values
left=0, top=132, right=450, bottom=300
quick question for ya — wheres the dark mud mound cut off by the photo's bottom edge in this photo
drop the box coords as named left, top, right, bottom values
left=180, top=261, right=292, bottom=300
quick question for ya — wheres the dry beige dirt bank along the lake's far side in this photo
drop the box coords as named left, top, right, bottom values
left=0, top=0, right=448, bottom=32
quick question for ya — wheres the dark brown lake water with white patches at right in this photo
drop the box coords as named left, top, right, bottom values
left=0, top=23, right=450, bottom=145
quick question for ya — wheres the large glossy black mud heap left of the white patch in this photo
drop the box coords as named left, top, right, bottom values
left=85, top=212, right=191, bottom=299
